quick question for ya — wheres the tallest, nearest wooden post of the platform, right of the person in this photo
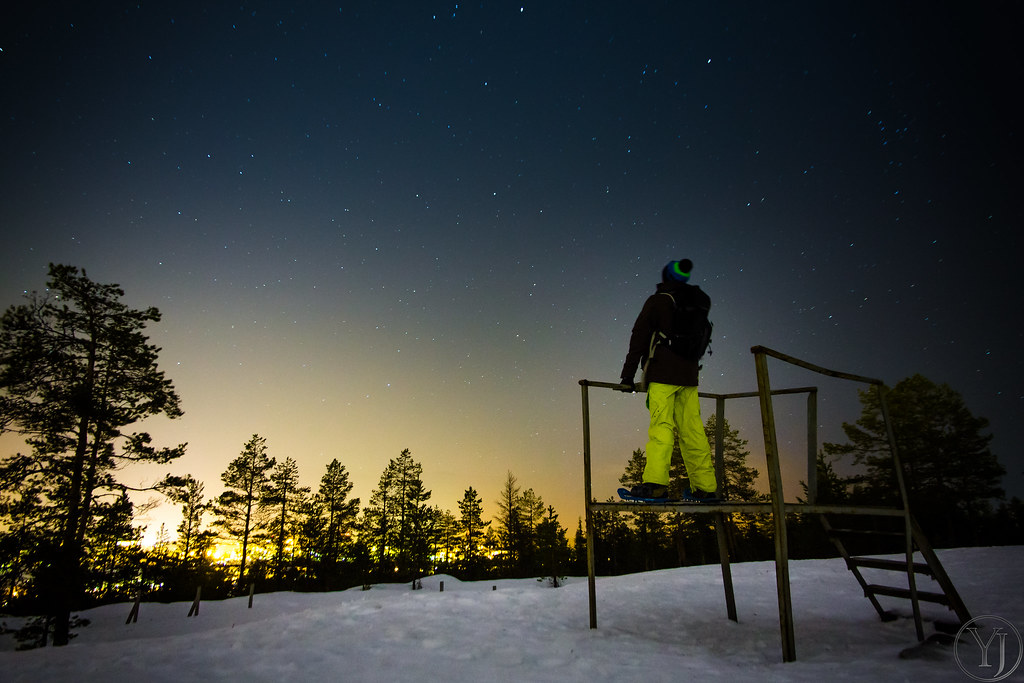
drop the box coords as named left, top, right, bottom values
left=751, top=346, right=797, bottom=661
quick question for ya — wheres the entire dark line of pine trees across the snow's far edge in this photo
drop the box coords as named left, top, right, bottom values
left=0, top=265, right=1024, bottom=645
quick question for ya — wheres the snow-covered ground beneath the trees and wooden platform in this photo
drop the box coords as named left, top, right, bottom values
left=0, top=547, right=1024, bottom=683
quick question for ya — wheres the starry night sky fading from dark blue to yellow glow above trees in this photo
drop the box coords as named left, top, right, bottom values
left=0, top=2, right=1024, bottom=533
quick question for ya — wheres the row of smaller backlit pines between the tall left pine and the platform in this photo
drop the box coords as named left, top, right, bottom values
left=145, top=434, right=569, bottom=599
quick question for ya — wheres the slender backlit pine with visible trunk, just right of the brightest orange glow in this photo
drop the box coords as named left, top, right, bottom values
left=216, top=434, right=276, bottom=588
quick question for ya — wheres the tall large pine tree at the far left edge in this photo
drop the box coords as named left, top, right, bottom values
left=0, top=264, right=184, bottom=645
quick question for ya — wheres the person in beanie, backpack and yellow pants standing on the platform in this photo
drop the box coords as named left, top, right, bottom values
left=620, top=259, right=720, bottom=502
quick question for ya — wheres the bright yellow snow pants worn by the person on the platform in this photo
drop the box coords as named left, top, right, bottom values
left=643, top=382, right=718, bottom=493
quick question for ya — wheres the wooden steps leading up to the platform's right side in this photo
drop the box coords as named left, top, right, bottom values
left=819, top=515, right=971, bottom=640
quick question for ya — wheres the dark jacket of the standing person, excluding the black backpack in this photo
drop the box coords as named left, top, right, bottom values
left=620, top=283, right=711, bottom=386
